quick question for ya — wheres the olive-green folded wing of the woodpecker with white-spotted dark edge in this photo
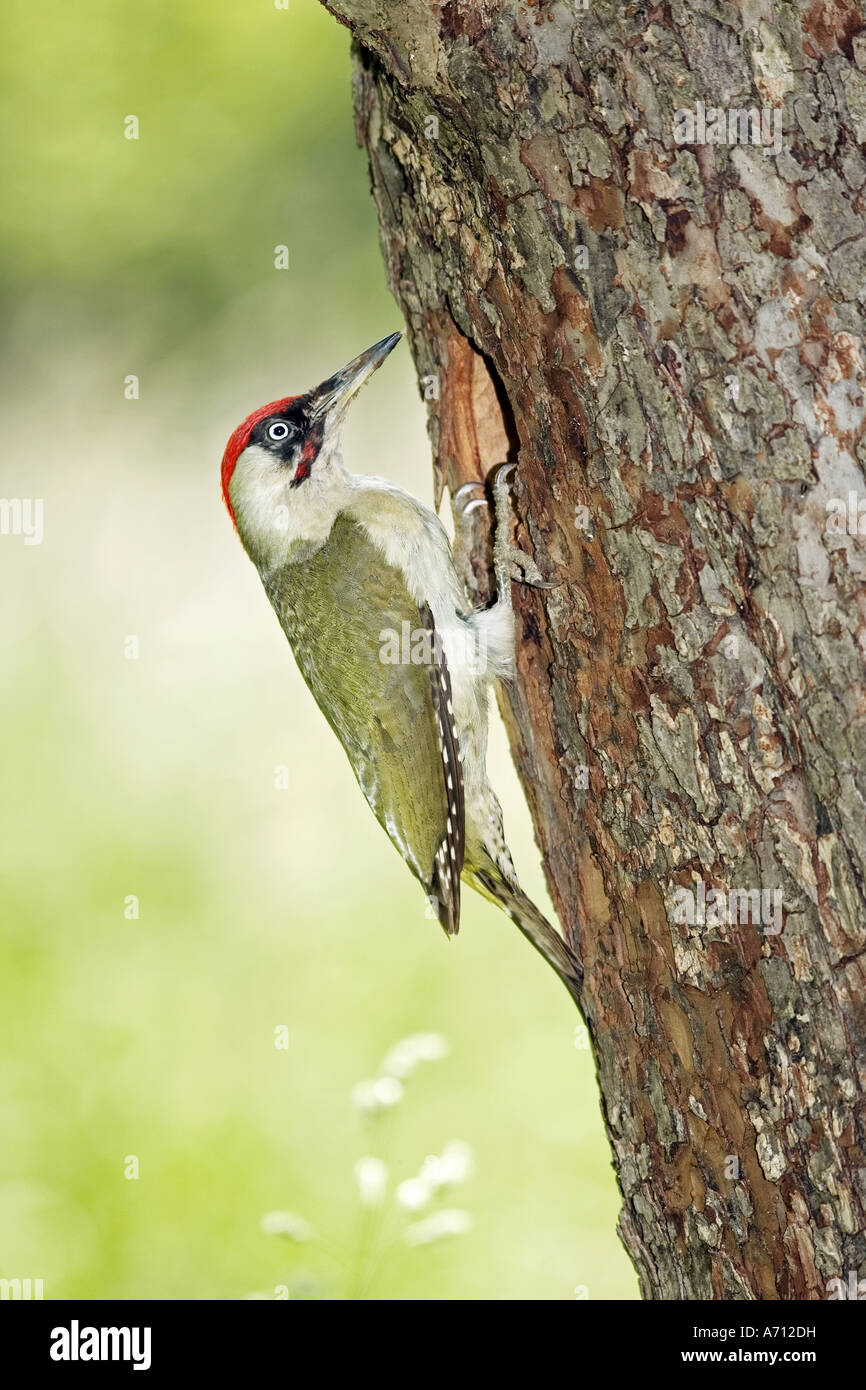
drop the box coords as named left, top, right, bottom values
left=265, top=516, right=464, bottom=934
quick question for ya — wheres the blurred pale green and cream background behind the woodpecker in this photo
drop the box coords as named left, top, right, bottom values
left=0, top=0, right=637, bottom=1300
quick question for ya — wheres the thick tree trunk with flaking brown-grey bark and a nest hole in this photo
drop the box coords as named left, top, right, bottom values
left=318, top=0, right=866, bottom=1300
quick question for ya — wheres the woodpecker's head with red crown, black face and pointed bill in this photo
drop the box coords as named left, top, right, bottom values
left=222, top=334, right=402, bottom=566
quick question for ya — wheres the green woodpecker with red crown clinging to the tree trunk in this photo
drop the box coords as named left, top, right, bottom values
left=222, top=334, right=581, bottom=999
